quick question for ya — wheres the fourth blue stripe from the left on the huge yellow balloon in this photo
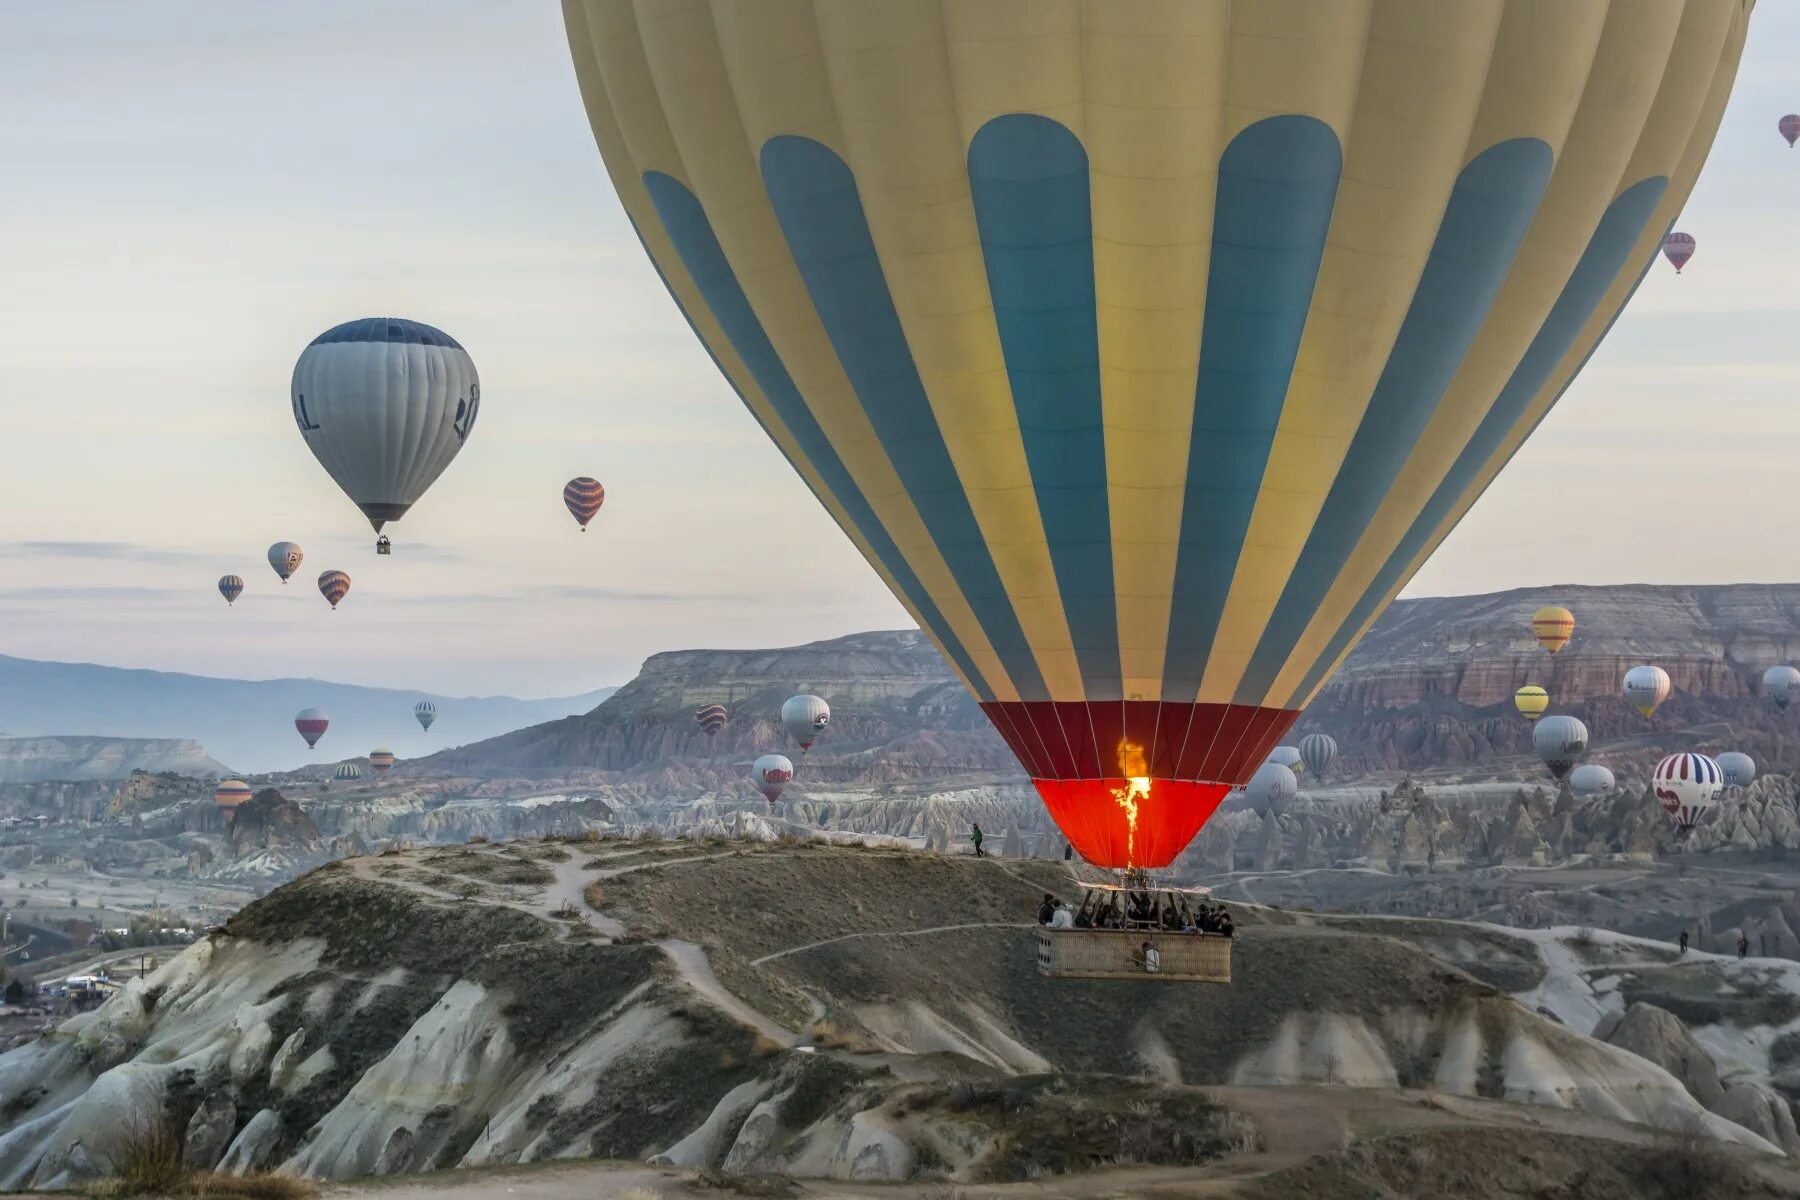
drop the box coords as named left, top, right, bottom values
left=1163, top=115, right=1343, bottom=703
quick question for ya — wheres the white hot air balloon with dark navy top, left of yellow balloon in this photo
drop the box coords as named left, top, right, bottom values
left=292, top=317, right=481, bottom=549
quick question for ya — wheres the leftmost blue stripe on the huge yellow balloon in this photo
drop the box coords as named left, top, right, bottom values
left=634, top=183, right=994, bottom=700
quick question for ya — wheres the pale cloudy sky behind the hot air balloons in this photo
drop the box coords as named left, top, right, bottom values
left=0, top=0, right=1800, bottom=696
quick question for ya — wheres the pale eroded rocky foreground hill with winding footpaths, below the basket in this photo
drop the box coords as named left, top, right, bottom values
left=0, top=840, right=1793, bottom=1196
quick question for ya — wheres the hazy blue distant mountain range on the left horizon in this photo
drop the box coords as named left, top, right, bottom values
left=0, top=655, right=617, bottom=774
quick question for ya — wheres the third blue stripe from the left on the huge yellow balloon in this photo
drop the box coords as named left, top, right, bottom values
left=968, top=113, right=1123, bottom=700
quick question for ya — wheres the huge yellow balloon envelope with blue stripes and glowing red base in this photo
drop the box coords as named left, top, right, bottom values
left=563, top=0, right=1748, bottom=869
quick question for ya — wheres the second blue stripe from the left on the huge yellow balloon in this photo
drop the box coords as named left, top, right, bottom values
left=761, top=135, right=1049, bottom=700
